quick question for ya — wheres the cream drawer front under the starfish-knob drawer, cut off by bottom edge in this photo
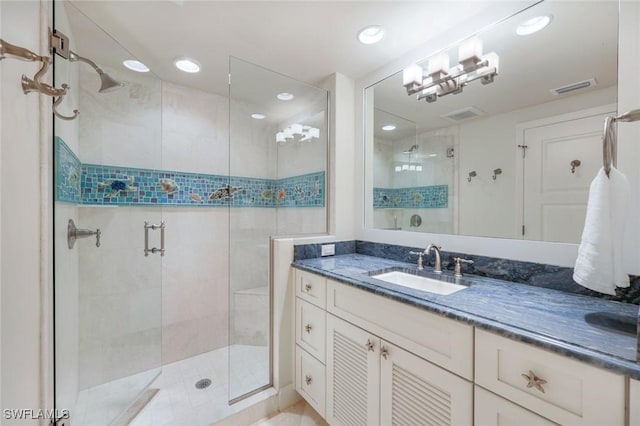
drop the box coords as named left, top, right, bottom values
left=475, top=386, right=557, bottom=426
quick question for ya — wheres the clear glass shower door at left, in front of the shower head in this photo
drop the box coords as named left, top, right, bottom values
left=53, top=1, right=162, bottom=425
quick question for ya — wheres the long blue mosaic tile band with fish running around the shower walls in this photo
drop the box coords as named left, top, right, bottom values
left=56, top=139, right=325, bottom=207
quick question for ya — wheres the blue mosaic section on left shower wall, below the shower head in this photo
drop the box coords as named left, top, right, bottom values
left=53, top=137, right=82, bottom=204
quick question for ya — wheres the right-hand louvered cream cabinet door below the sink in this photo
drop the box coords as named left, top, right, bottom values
left=380, top=341, right=473, bottom=426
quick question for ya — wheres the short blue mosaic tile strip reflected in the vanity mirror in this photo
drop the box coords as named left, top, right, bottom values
left=373, top=185, right=449, bottom=209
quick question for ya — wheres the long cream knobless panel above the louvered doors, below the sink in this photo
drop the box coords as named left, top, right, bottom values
left=327, top=280, right=473, bottom=380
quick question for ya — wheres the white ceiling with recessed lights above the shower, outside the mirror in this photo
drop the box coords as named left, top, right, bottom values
left=66, top=0, right=510, bottom=95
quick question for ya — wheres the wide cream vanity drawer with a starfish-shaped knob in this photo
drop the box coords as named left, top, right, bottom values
left=475, top=329, right=625, bottom=425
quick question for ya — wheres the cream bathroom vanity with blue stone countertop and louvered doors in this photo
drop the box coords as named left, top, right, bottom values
left=293, top=254, right=640, bottom=426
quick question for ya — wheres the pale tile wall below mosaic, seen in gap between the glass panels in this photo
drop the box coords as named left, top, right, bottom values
left=162, top=207, right=229, bottom=364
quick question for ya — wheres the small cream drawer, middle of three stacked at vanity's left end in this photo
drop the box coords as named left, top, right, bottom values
left=296, top=297, right=327, bottom=364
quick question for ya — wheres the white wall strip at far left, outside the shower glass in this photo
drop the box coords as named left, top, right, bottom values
left=0, top=1, right=51, bottom=425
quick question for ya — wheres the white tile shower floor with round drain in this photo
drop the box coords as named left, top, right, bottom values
left=74, top=345, right=269, bottom=426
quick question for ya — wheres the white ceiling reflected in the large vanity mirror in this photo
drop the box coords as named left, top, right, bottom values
left=374, top=1, right=618, bottom=139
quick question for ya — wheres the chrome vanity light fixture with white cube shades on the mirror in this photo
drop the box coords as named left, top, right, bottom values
left=402, top=37, right=500, bottom=102
